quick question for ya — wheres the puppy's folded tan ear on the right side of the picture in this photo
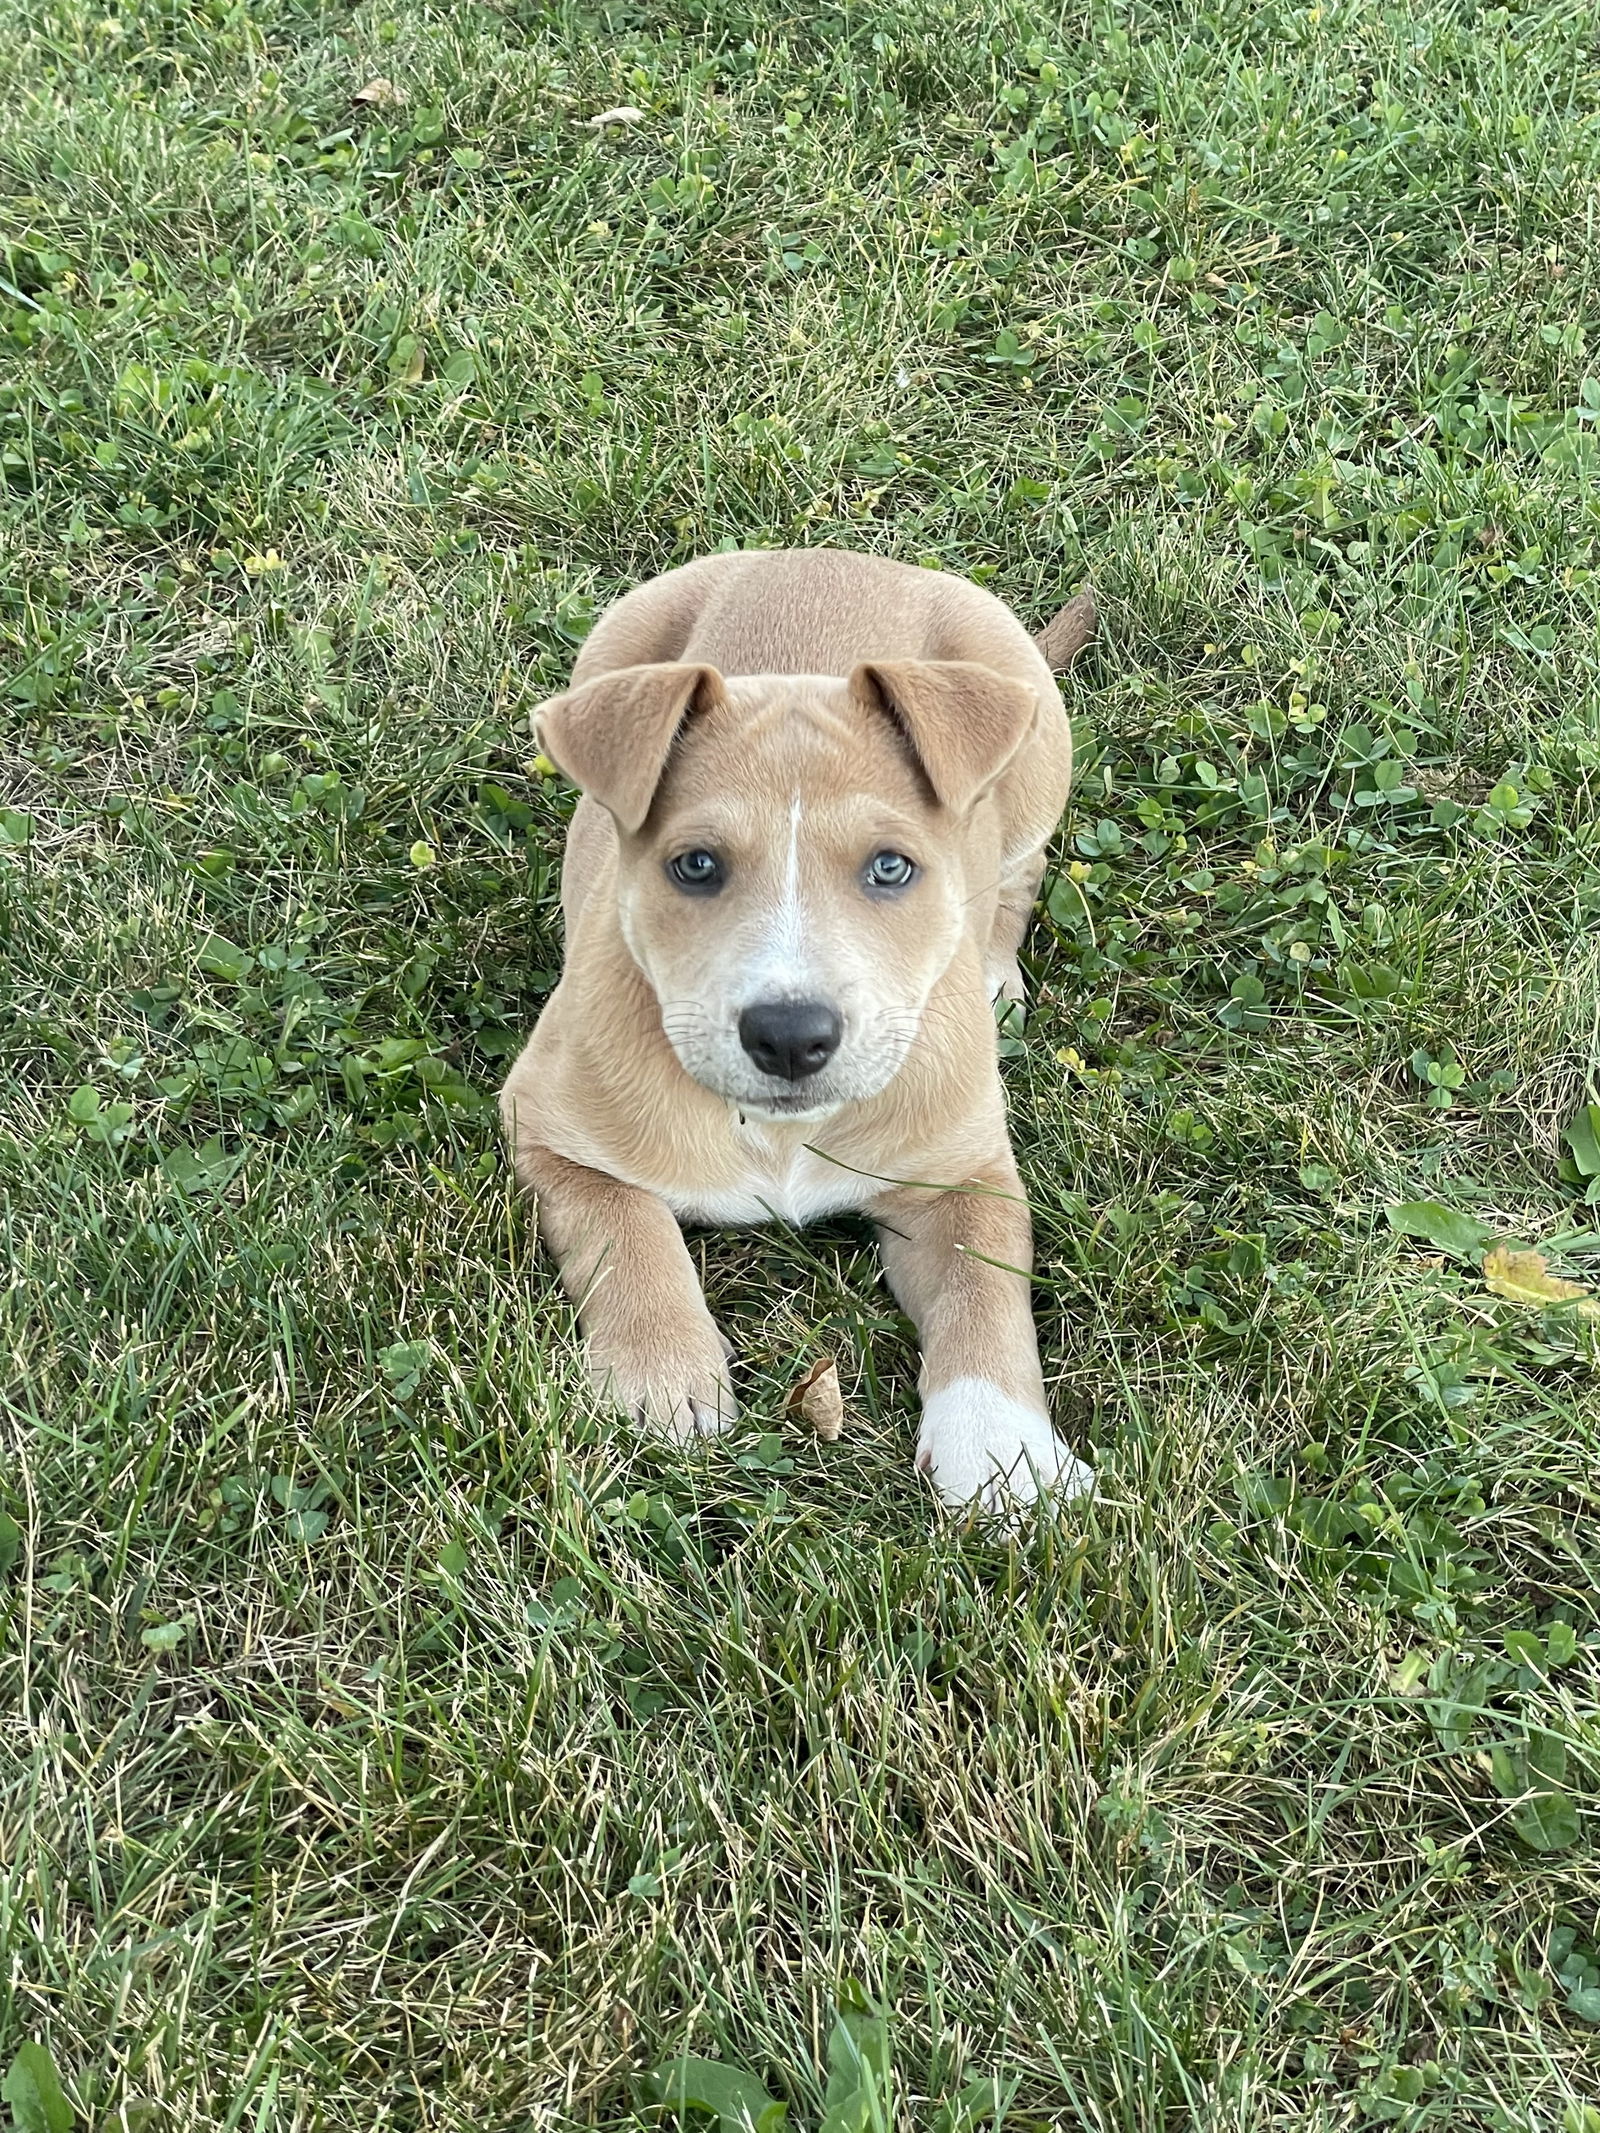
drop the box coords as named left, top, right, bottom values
left=849, top=659, right=1039, bottom=815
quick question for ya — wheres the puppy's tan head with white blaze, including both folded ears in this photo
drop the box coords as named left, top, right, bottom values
left=538, top=661, right=1035, bottom=1120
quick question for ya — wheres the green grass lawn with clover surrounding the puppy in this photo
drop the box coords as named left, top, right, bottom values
left=0, top=0, right=1600, bottom=2133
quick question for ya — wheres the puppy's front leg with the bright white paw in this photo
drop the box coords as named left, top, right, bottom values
left=873, top=1156, right=1094, bottom=1510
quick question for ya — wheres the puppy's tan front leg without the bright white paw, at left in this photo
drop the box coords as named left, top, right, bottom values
left=516, top=1145, right=736, bottom=1438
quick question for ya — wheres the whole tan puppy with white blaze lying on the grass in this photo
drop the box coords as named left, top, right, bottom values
left=501, top=548, right=1094, bottom=1508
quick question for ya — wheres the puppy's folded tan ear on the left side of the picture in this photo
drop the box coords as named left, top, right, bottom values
left=533, top=661, right=723, bottom=836
